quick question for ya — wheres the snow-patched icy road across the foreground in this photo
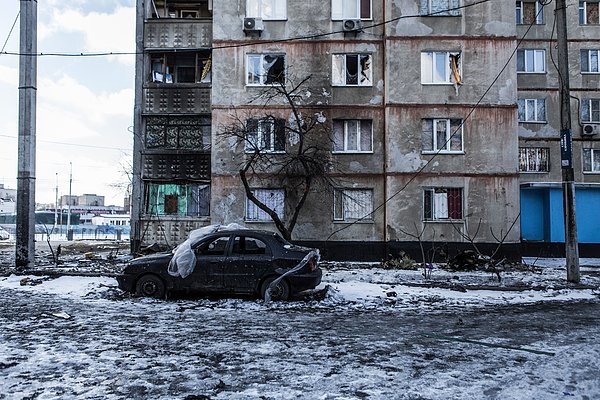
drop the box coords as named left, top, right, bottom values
left=0, top=289, right=600, bottom=400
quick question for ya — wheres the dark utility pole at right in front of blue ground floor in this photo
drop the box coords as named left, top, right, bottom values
left=555, top=0, right=579, bottom=283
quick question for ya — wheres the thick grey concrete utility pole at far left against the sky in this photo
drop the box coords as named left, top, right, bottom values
left=15, top=0, right=37, bottom=268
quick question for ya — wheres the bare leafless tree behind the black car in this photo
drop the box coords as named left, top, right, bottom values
left=218, top=76, right=333, bottom=240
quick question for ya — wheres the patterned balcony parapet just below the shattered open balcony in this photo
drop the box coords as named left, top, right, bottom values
left=143, top=83, right=211, bottom=115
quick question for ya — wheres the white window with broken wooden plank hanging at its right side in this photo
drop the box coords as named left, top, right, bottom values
left=421, top=51, right=462, bottom=85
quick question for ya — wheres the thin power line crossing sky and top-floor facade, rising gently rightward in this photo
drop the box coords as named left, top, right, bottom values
left=0, top=0, right=491, bottom=57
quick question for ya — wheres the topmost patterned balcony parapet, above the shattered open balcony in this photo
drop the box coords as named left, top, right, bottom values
left=144, top=18, right=212, bottom=50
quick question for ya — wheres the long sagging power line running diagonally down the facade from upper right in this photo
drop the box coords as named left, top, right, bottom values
left=327, top=0, right=552, bottom=240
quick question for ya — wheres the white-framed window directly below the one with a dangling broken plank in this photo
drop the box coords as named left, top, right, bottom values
left=422, top=118, right=463, bottom=153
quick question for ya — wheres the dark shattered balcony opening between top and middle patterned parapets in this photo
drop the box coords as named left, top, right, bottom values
left=150, top=51, right=211, bottom=83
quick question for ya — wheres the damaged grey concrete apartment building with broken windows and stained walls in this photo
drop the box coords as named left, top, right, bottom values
left=132, top=0, right=600, bottom=259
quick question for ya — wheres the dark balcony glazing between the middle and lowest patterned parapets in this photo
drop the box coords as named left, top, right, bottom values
left=145, top=117, right=211, bottom=150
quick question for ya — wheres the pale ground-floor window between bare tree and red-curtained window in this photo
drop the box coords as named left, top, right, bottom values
left=333, top=189, right=373, bottom=221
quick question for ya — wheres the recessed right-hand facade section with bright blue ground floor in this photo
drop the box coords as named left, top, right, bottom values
left=517, top=0, right=600, bottom=244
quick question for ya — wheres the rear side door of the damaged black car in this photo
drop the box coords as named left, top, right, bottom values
left=223, top=235, right=273, bottom=293
